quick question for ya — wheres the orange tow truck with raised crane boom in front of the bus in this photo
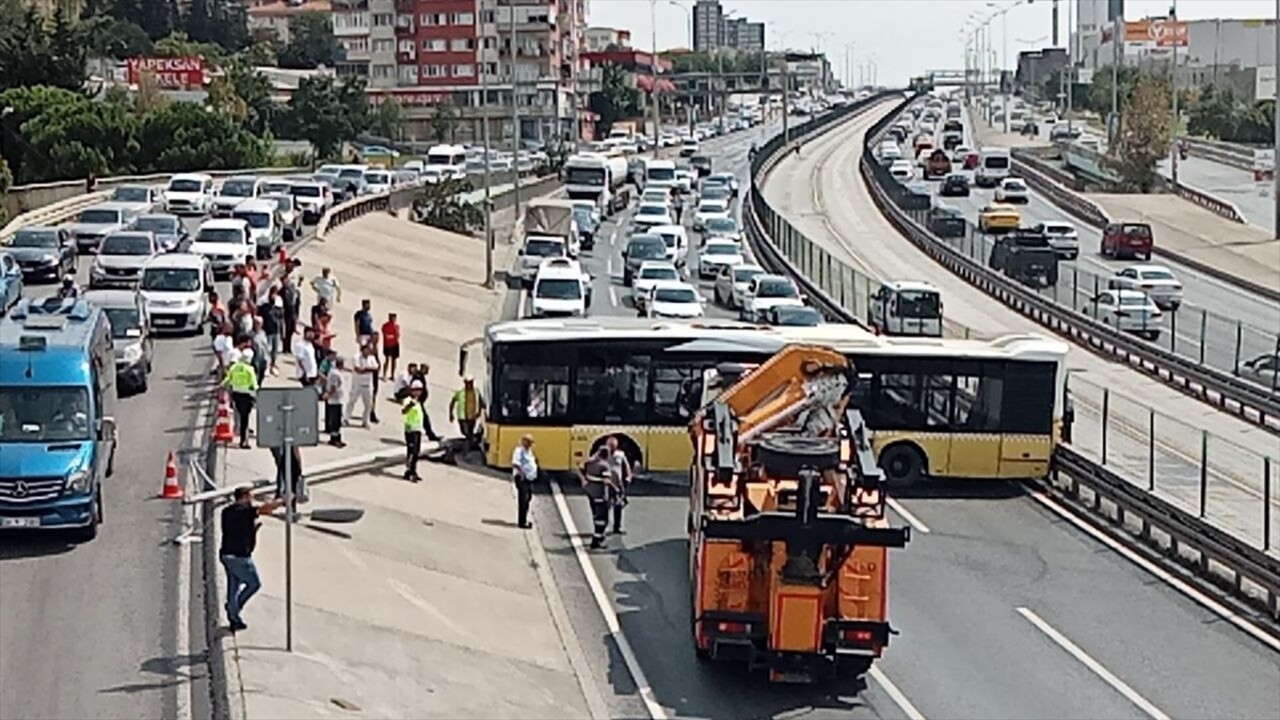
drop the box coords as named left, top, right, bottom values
left=689, top=346, right=910, bottom=682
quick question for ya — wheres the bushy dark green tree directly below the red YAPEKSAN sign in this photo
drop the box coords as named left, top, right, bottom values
left=137, top=102, right=271, bottom=173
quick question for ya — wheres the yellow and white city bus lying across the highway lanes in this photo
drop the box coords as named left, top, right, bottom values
left=477, top=316, right=1068, bottom=486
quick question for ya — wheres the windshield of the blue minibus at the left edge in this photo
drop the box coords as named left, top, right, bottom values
left=0, top=386, right=90, bottom=442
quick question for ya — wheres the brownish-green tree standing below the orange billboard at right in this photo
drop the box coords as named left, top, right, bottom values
left=1103, top=78, right=1171, bottom=192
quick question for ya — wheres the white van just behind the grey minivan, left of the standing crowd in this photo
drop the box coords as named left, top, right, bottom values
left=138, top=252, right=213, bottom=333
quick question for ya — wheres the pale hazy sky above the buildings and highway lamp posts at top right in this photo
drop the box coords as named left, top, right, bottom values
left=588, top=0, right=1276, bottom=86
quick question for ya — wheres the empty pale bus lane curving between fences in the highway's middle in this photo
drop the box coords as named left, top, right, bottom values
left=764, top=105, right=1280, bottom=544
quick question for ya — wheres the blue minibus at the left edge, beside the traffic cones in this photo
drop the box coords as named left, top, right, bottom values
left=0, top=297, right=116, bottom=541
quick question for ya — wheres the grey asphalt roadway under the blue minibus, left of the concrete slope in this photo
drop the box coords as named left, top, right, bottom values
left=0, top=207, right=311, bottom=720
